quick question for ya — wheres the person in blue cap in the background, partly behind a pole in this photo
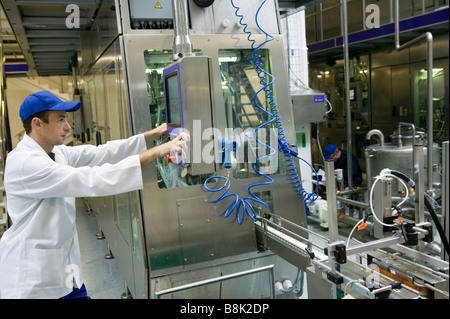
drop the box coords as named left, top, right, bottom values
left=323, top=144, right=363, bottom=187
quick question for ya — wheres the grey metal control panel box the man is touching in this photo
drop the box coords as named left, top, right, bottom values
left=163, top=56, right=215, bottom=175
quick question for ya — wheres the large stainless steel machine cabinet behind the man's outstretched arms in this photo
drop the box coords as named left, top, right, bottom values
left=79, top=0, right=307, bottom=298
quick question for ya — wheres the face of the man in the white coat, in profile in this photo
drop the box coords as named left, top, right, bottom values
left=41, top=111, right=72, bottom=145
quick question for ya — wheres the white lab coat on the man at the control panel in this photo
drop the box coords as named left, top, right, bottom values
left=0, top=134, right=146, bottom=298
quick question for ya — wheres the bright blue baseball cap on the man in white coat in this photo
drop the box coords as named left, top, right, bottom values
left=19, top=91, right=81, bottom=123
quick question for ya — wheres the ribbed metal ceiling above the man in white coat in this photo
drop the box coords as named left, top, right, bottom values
left=0, top=0, right=323, bottom=76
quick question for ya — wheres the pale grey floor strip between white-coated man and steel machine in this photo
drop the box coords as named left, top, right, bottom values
left=77, top=199, right=125, bottom=299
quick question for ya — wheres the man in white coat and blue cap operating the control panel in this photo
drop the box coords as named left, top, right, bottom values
left=0, top=91, right=190, bottom=299
